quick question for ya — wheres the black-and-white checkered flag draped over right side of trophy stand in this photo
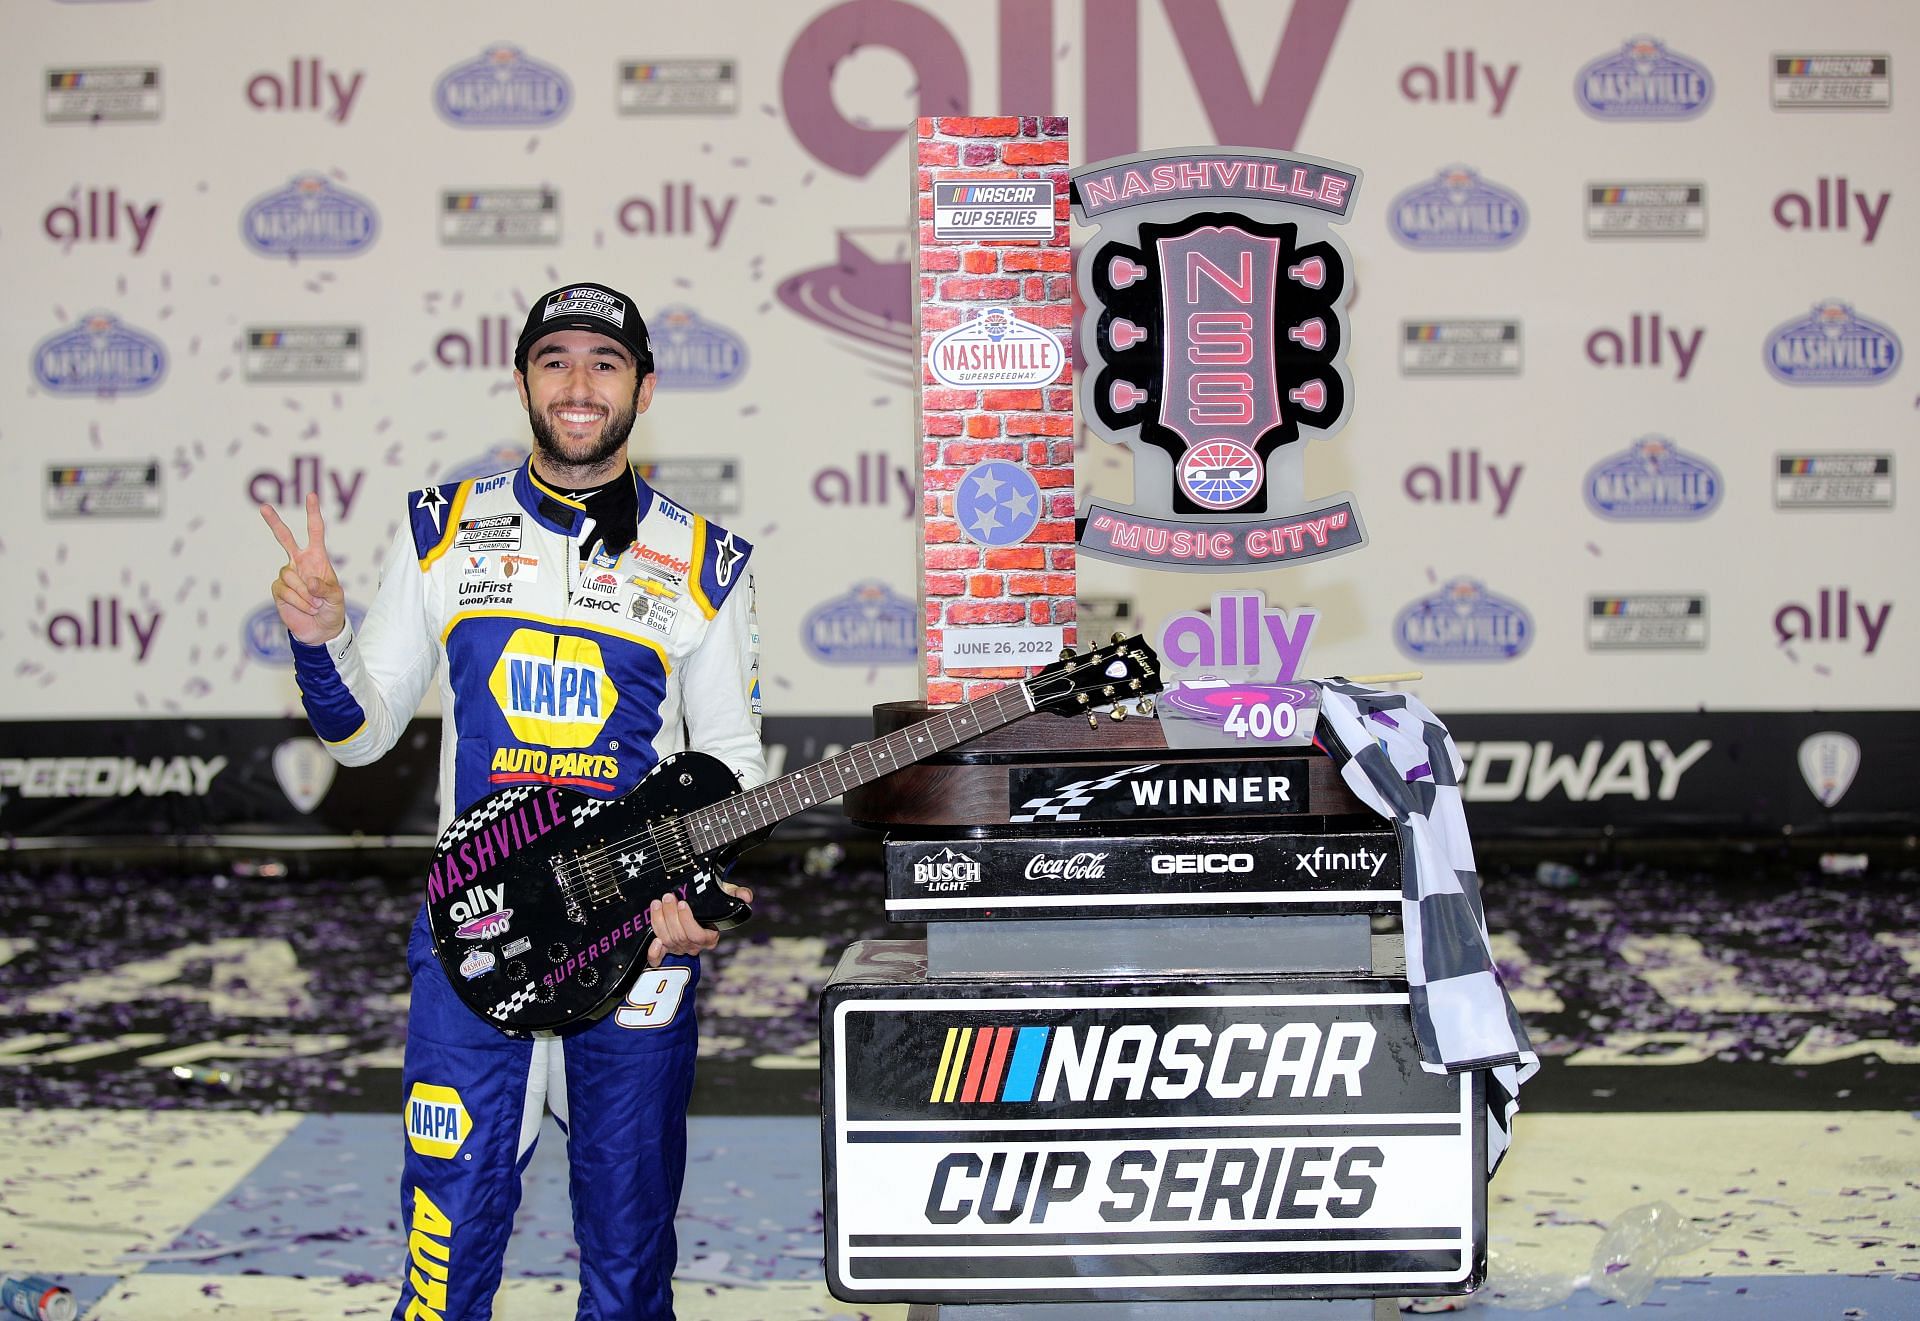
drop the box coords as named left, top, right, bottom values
left=1315, top=680, right=1540, bottom=1173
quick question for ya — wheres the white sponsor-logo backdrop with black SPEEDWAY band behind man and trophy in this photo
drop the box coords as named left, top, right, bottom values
left=0, top=0, right=1920, bottom=835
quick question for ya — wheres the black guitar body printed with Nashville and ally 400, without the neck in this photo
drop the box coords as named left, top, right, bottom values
left=426, top=753, right=764, bottom=1033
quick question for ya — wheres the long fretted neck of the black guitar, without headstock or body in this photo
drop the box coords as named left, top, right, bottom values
left=680, top=684, right=1033, bottom=853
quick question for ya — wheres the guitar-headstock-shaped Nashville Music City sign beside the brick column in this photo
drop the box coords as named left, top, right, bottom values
left=1071, top=148, right=1367, bottom=570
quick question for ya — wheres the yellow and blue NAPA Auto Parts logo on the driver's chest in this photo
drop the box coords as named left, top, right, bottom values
left=488, top=628, right=620, bottom=783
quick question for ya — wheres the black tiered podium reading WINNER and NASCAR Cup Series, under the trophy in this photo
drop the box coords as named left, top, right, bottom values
left=820, top=703, right=1486, bottom=1321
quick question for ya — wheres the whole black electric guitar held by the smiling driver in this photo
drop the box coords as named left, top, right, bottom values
left=426, top=636, right=1160, bottom=1031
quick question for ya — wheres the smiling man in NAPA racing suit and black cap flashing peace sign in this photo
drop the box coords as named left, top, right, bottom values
left=261, top=284, right=766, bottom=1321
